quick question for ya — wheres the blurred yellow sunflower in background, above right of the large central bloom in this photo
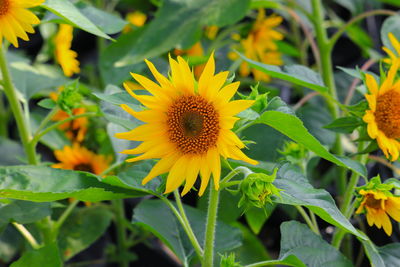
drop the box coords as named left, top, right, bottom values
left=229, top=9, right=283, bottom=82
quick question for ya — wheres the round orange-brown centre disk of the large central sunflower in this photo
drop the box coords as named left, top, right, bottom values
left=167, top=95, right=219, bottom=154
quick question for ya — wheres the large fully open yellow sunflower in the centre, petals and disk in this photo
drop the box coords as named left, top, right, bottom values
left=116, top=55, right=258, bottom=196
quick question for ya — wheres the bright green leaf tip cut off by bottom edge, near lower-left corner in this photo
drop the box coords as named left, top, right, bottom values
left=11, top=243, right=63, bottom=267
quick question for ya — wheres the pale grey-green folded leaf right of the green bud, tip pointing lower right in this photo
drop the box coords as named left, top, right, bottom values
left=274, top=163, right=365, bottom=241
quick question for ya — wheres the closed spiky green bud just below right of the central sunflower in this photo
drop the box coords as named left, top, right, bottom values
left=238, top=169, right=282, bottom=209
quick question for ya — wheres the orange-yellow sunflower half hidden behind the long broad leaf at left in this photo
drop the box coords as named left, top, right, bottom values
left=52, top=143, right=111, bottom=175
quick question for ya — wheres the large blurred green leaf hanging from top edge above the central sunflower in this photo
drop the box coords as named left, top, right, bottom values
left=113, top=0, right=250, bottom=66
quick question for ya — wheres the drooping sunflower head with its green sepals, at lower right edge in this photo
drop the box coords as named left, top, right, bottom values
left=356, top=176, right=400, bottom=235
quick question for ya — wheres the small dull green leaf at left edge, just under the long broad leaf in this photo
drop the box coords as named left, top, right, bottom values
left=0, top=200, right=51, bottom=224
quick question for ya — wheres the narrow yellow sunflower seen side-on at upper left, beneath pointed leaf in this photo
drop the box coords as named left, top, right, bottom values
left=54, top=24, right=80, bottom=77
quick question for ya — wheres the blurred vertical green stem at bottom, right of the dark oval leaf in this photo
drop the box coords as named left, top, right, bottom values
left=112, top=199, right=129, bottom=267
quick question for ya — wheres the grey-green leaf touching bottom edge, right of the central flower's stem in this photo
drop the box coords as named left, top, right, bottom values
left=279, top=221, right=353, bottom=267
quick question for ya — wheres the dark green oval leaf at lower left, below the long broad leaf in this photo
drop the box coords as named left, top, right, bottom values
left=59, top=206, right=113, bottom=260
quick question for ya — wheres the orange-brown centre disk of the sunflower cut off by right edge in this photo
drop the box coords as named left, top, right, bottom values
left=375, top=90, right=400, bottom=139
